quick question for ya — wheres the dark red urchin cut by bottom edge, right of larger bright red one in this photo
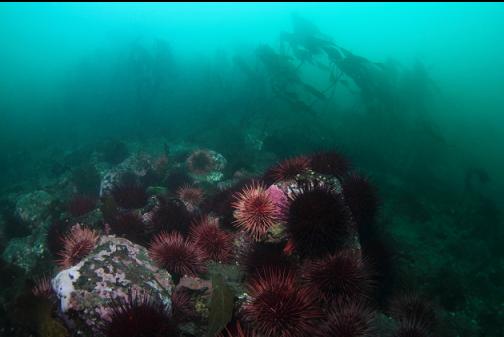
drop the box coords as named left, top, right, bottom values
left=323, top=301, right=375, bottom=337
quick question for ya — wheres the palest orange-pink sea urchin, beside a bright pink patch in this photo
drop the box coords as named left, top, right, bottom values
left=231, top=182, right=282, bottom=240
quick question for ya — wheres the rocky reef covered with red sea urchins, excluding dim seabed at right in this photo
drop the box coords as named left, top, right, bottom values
left=0, top=144, right=436, bottom=337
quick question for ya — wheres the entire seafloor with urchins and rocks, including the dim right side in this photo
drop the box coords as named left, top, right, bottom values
left=0, top=139, right=504, bottom=337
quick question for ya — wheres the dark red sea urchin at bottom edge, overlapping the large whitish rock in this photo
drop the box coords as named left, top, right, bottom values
left=102, top=293, right=176, bottom=337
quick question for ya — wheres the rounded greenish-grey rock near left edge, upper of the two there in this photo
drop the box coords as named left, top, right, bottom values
left=15, top=191, right=54, bottom=230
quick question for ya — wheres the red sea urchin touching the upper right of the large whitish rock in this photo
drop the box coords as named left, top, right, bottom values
left=149, top=232, right=205, bottom=277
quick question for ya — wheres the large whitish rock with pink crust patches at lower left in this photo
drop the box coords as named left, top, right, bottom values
left=52, top=236, right=173, bottom=336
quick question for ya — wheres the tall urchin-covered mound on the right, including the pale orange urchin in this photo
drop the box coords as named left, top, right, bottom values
left=228, top=152, right=438, bottom=337
